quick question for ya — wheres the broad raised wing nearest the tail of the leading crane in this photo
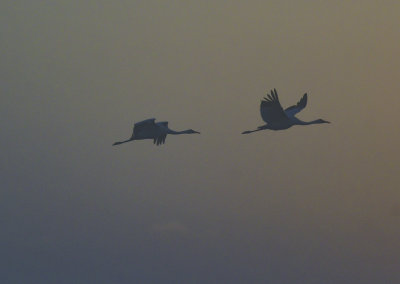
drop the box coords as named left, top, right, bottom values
left=260, top=89, right=288, bottom=123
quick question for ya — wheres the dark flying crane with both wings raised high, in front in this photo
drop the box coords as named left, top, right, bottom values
left=242, top=89, right=330, bottom=134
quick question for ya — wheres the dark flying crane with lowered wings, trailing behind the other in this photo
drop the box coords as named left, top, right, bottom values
left=113, top=118, right=200, bottom=146
